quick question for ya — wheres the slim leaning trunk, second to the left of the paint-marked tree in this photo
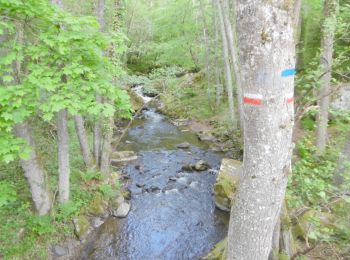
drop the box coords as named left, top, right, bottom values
left=216, top=0, right=237, bottom=128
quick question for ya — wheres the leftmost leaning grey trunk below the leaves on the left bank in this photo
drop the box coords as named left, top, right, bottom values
left=14, top=122, right=51, bottom=215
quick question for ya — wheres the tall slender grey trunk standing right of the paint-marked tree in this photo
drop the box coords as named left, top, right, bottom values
left=316, top=0, right=338, bottom=155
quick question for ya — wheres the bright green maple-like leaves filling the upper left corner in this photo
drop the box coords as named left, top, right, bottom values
left=0, top=0, right=130, bottom=162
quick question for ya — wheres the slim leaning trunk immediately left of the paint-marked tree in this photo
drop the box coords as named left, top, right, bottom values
left=219, top=0, right=244, bottom=133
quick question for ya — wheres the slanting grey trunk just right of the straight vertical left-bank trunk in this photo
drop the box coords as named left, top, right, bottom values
left=74, top=115, right=93, bottom=168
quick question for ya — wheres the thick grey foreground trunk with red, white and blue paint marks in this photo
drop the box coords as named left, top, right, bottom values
left=228, top=0, right=295, bottom=260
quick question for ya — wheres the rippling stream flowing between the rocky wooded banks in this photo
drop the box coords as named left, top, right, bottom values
left=81, top=88, right=228, bottom=260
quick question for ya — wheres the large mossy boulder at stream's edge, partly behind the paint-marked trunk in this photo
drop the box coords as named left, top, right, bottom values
left=214, top=159, right=242, bottom=212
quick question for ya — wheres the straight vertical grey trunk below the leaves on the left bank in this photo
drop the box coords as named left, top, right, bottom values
left=57, top=109, right=70, bottom=203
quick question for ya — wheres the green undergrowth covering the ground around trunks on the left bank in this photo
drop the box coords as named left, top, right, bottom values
left=0, top=119, right=120, bottom=259
